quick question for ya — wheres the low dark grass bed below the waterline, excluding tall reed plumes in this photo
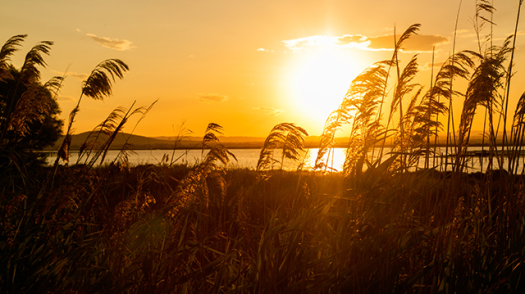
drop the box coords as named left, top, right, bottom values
left=0, top=162, right=525, bottom=293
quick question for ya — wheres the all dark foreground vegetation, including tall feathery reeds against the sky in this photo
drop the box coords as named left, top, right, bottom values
left=0, top=1, right=525, bottom=293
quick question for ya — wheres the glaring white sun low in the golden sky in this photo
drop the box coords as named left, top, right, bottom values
left=287, top=48, right=359, bottom=125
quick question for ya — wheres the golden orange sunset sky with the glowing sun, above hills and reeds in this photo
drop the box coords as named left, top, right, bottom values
left=0, top=0, right=525, bottom=136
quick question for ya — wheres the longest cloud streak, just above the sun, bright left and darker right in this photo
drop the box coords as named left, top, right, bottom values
left=283, top=35, right=449, bottom=52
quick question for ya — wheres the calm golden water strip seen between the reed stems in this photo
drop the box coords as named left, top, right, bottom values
left=47, top=147, right=523, bottom=172
